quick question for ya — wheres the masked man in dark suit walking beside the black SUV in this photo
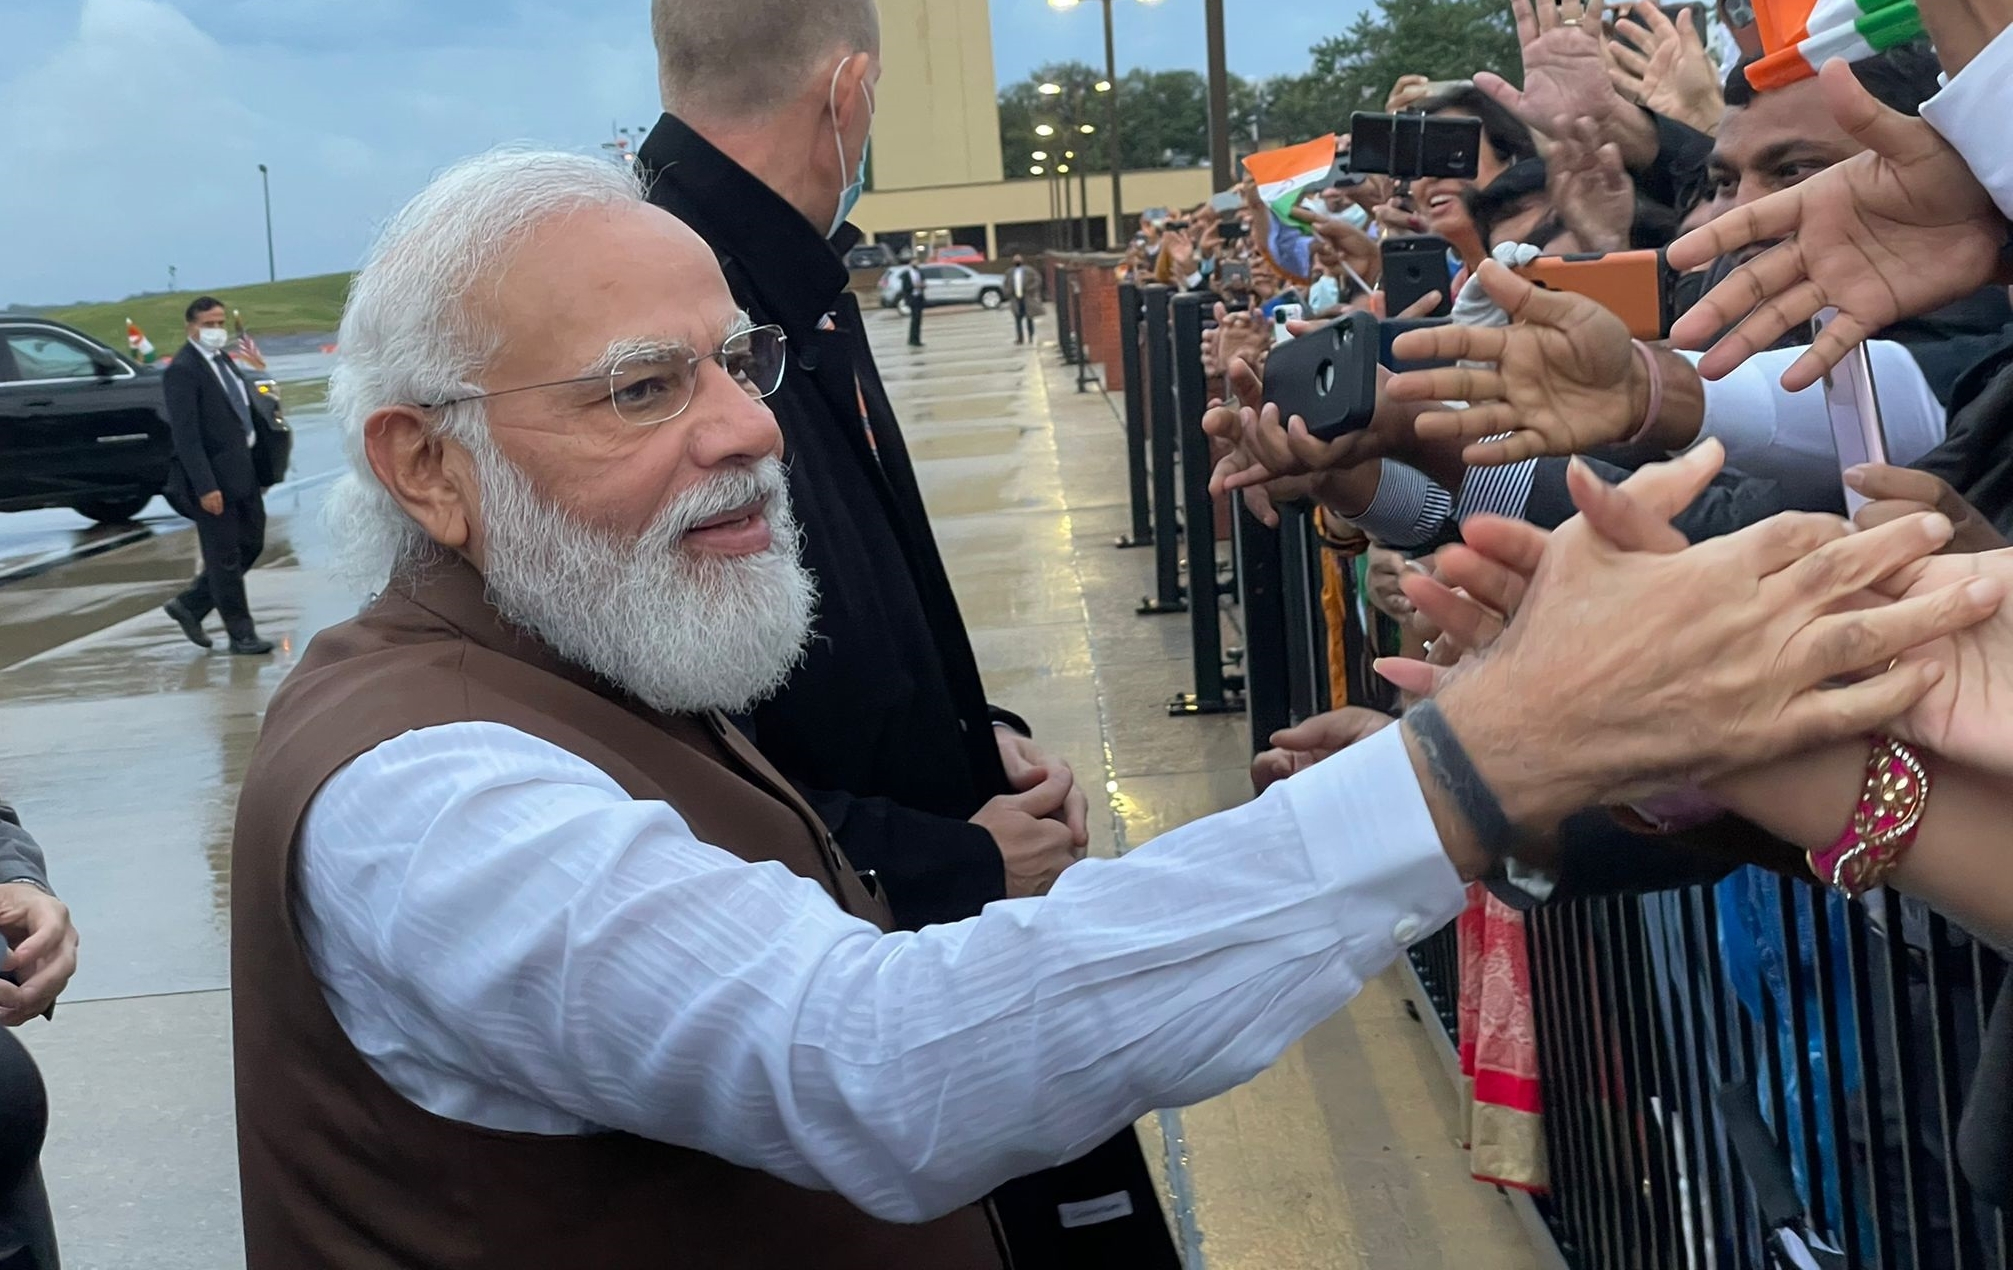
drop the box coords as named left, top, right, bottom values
left=165, top=296, right=272, bottom=656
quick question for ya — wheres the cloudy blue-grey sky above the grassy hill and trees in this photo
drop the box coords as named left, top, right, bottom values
left=0, top=0, right=1361, bottom=306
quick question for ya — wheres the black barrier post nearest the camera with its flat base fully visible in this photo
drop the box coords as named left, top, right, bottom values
left=1168, top=292, right=1244, bottom=719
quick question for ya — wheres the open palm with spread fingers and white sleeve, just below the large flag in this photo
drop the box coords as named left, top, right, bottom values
left=1669, top=62, right=2007, bottom=392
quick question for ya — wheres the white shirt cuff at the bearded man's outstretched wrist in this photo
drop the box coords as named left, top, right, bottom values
left=1284, top=725, right=1467, bottom=948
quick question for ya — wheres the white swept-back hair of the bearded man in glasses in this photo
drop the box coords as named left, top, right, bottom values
left=324, top=149, right=642, bottom=590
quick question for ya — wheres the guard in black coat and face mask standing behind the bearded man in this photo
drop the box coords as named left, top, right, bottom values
left=638, top=0, right=1180, bottom=1270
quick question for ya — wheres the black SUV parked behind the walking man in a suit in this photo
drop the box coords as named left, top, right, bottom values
left=0, top=318, right=294, bottom=525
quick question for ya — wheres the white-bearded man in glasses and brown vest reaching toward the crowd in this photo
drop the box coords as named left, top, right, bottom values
left=220, top=151, right=1999, bottom=1270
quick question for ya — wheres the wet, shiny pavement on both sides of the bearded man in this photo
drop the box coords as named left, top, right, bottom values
left=0, top=310, right=1534, bottom=1270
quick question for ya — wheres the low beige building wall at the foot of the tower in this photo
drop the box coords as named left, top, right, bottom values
left=851, top=168, right=1214, bottom=256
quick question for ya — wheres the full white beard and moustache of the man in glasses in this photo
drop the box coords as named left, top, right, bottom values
left=475, top=447, right=817, bottom=715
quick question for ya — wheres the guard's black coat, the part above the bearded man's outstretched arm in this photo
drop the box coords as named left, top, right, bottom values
left=640, top=115, right=1009, bottom=928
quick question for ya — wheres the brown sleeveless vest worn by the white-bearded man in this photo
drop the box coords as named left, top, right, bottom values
left=231, top=562, right=1007, bottom=1270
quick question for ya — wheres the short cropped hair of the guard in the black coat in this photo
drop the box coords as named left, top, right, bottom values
left=650, top=0, right=880, bottom=119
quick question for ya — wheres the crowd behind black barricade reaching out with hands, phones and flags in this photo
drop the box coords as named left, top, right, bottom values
left=1087, top=0, right=2013, bottom=1266
